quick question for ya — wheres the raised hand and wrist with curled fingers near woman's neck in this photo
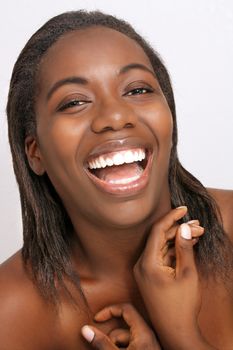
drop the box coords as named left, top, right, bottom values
left=134, top=207, right=215, bottom=350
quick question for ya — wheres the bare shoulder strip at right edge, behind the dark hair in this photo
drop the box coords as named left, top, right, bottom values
left=207, top=188, right=233, bottom=240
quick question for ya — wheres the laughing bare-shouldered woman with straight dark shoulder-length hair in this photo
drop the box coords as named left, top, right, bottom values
left=0, top=11, right=233, bottom=350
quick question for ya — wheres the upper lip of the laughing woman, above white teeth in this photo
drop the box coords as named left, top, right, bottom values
left=85, top=137, right=153, bottom=164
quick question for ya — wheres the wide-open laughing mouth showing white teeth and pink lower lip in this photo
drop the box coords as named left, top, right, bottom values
left=86, top=147, right=152, bottom=195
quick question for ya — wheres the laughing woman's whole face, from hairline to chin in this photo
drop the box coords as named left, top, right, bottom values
left=33, top=27, right=172, bottom=227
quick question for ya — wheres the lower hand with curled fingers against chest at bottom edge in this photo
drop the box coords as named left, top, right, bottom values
left=82, top=304, right=161, bottom=350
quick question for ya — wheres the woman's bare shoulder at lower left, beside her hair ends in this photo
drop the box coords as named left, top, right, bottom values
left=0, top=252, right=62, bottom=350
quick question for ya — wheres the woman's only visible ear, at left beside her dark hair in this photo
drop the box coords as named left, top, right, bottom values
left=25, top=136, right=45, bottom=175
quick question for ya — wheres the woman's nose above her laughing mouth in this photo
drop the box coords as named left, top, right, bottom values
left=91, top=100, right=137, bottom=133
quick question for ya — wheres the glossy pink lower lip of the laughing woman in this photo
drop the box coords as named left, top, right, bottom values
left=85, top=154, right=152, bottom=196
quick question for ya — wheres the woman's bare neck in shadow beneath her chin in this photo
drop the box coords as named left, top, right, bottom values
left=68, top=202, right=170, bottom=279
